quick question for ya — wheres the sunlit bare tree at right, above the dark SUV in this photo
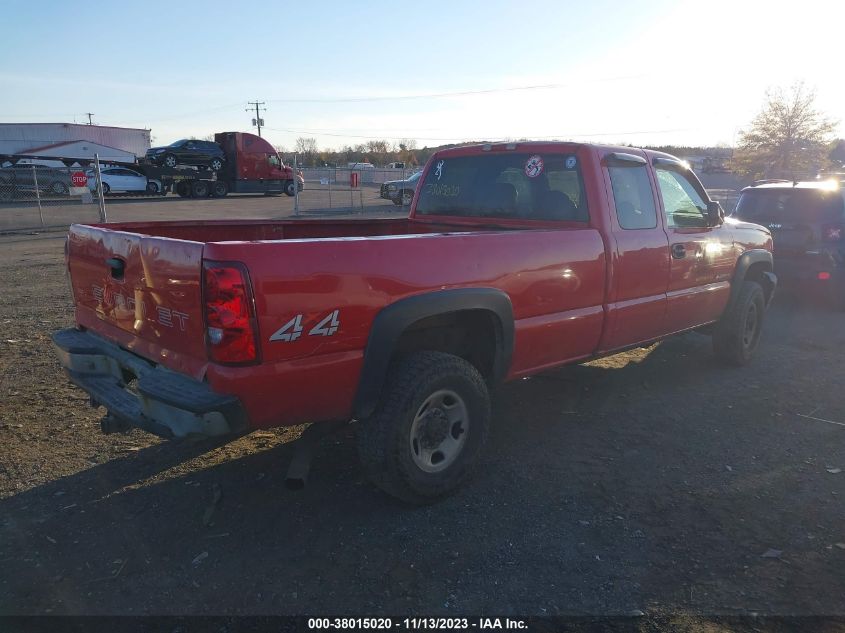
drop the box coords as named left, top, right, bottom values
left=734, top=82, right=836, bottom=178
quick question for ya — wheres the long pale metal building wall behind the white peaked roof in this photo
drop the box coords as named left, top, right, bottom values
left=0, top=123, right=150, bottom=156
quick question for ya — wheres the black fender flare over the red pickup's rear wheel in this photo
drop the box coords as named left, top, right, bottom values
left=352, top=288, right=514, bottom=419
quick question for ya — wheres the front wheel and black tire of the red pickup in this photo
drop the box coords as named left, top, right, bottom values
left=713, top=281, right=766, bottom=366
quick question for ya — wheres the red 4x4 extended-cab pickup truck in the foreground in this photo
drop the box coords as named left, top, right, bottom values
left=53, top=142, right=777, bottom=502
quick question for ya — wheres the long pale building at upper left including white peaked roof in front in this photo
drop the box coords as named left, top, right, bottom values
left=0, top=123, right=150, bottom=161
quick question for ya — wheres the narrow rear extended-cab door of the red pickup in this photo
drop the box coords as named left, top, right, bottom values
left=601, top=150, right=670, bottom=351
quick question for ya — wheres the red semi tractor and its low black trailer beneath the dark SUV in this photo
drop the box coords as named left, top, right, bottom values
left=132, top=132, right=303, bottom=198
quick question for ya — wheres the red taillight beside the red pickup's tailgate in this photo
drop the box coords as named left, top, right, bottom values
left=203, top=261, right=259, bottom=365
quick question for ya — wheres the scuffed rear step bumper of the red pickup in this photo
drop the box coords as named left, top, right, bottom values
left=53, top=328, right=248, bottom=438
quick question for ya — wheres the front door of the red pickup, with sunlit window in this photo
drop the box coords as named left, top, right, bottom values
left=653, top=157, right=734, bottom=333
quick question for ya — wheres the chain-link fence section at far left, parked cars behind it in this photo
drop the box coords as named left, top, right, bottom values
left=0, top=163, right=102, bottom=232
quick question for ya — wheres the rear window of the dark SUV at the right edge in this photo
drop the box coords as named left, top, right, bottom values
left=732, top=188, right=845, bottom=224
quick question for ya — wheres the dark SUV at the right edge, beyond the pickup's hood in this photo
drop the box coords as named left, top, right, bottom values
left=732, top=181, right=845, bottom=308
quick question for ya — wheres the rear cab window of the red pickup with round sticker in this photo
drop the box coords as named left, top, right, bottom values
left=416, top=152, right=589, bottom=222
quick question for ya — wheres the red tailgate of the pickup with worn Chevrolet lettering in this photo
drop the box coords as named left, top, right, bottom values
left=68, top=225, right=208, bottom=378
